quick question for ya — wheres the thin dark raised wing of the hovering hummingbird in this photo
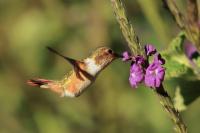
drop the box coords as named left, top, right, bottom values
left=47, top=47, right=83, bottom=80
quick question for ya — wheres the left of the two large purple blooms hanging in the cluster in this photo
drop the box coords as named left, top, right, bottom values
left=129, top=63, right=144, bottom=88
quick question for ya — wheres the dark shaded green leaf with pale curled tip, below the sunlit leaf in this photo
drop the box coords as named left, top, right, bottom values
left=169, top=70, right=200, bottom=111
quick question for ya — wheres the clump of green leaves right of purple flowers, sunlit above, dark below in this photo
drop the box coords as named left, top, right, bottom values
left=161, top=32, right=200, bottom=111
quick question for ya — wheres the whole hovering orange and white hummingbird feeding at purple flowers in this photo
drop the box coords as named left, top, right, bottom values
left=27, top=47, right=122, bottom=97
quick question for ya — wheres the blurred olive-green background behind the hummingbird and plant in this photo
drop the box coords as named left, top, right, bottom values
left=0, top=0, right=200, bottom=133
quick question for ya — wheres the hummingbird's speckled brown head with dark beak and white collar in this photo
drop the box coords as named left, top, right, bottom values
left=85, top=47, right=122, bottom=75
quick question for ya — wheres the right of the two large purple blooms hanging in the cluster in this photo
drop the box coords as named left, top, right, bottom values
left=144, top=61, right=165, bottom=88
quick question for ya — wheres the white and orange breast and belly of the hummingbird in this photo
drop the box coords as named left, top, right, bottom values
left=63, top=58, right=102, bottom=97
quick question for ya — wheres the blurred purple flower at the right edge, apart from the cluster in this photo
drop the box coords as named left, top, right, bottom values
left=184, top=41, right=198, bottom=60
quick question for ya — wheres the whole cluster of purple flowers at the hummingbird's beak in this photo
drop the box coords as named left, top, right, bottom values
left=122, top=44, right=165, bottom=88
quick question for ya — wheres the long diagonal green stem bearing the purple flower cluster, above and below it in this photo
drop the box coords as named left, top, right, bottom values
left=111, top=0, right=187, bottom=133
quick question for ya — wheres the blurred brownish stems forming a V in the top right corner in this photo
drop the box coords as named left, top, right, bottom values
left=163, top=0, right=200, bottom=51
